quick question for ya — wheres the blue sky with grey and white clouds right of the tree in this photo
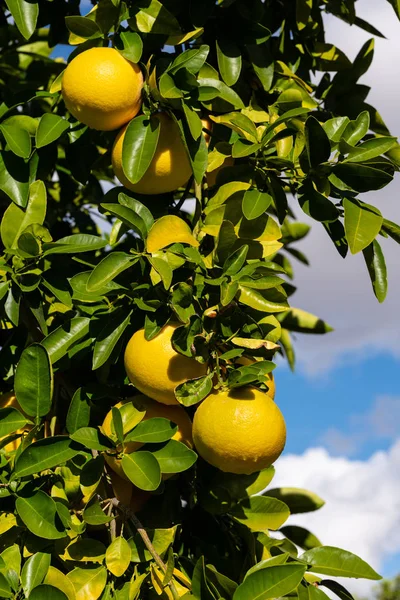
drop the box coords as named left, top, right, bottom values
left=53, top=0, right=400, bottom=599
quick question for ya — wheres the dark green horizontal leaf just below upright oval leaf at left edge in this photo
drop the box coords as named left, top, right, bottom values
left=14, top=435, right=82, bottom=478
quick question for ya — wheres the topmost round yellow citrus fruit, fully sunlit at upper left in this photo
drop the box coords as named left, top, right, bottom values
left=61, top=48, right=143, bottom=131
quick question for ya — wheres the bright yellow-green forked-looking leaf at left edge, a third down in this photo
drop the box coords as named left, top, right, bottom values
left=1, top=180, right=46, bottom=248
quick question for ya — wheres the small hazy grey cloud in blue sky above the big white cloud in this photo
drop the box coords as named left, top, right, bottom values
left=319, top=396, right=400, bottom=456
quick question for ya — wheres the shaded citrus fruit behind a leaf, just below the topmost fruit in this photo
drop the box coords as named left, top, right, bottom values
left=111, top=113, right=192, bottom=194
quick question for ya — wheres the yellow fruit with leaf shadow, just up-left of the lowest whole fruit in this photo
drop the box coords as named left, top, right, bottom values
left=125, top=323, right=207, bottom=404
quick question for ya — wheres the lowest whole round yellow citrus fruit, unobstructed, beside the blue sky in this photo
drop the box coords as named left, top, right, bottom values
left=193, top=387, right=286, bottom=475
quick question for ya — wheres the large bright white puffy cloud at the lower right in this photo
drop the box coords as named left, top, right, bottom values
left=273, top=440, right=400, bottom=598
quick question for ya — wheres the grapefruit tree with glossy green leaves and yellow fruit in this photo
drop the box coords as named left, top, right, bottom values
left=0, top=0, right=400, bottom=600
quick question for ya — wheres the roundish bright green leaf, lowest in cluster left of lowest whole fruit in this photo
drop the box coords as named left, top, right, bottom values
left=121, top=451, right=161, bottom=492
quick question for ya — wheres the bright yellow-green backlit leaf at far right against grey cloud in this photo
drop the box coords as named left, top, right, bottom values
left=343, top=198, right=383, bottom=254
